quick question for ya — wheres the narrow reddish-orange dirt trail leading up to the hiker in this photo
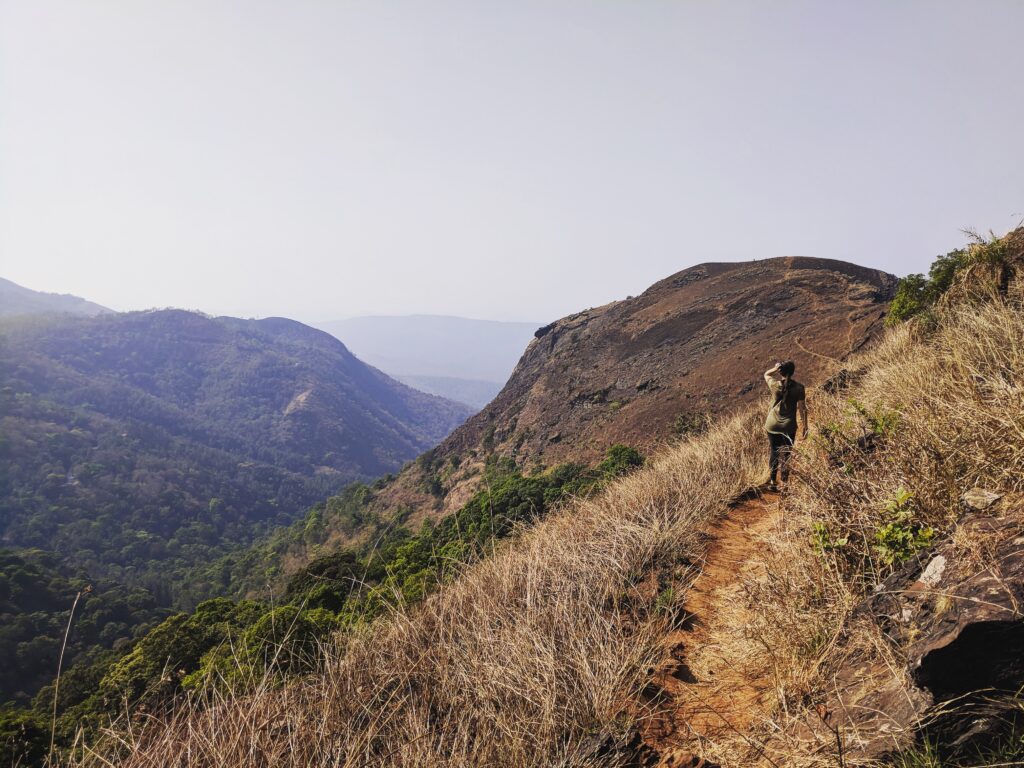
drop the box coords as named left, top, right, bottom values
left=645, top=494, right=781, bottom=768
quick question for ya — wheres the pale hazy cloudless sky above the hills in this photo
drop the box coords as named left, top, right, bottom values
left=0, top=0, right=1024, bottom=322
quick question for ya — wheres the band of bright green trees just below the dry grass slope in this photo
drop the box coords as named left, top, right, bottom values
left=0, top=445, right=643, bottom=761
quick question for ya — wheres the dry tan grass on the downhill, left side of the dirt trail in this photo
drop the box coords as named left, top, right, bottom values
left=76, top=413, right=764, bottom=768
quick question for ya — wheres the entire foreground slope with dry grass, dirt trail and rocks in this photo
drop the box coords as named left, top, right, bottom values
left=64, top=225, right=1024, bottom=766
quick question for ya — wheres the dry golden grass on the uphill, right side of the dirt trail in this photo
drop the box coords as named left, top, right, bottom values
left=706, top=274, right=1024, bottom=766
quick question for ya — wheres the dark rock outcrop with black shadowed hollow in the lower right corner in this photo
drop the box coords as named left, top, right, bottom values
left=830, top=501, right=1024, bottom=757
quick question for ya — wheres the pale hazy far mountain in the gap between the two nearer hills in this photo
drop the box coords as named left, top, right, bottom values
left=316, top=314, right=541, bottom=408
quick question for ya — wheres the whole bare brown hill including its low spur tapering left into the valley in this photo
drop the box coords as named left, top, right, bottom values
left=226, top=257, right=897, bottom=592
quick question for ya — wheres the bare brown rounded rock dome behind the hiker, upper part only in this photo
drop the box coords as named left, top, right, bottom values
left=441, top=257, right=896, bottom=464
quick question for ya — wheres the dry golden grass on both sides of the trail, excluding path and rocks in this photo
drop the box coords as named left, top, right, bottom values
left=68, top=230, right=1024, bottom=768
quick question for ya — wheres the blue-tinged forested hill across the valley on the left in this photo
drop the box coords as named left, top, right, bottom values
left=0, top=310, right=467, bottom=605
